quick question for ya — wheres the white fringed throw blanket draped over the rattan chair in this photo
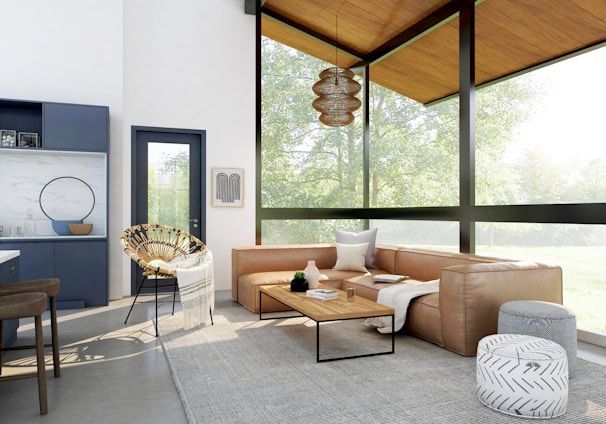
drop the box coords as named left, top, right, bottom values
left=177, top=250, right=215, bottom=330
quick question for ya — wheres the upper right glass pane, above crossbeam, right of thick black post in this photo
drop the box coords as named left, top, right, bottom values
left=476, top=47, right=606, bottom=205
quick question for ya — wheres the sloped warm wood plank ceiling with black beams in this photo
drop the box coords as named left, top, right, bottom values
left=261, top=0, right=606, bottom=104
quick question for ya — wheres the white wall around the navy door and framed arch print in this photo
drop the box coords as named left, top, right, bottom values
left=0, top=0, right=255, bottom=299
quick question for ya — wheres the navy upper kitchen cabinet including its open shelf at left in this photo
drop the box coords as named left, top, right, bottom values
left=0, top=99, right=109, bottom=152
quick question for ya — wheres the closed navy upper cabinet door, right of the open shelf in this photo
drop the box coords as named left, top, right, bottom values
left=42, top=103, right=109, bottom=152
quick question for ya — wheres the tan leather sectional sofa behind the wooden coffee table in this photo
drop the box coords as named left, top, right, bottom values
left=232, top=244, right=563, bottom=356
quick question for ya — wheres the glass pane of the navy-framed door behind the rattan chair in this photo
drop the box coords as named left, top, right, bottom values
left=147, top=143, right=190, bottom=231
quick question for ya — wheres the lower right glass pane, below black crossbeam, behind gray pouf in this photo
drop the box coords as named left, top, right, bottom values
left=476, top=222, right=606, bottom=333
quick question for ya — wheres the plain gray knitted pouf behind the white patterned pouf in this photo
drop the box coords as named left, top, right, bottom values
left=498, top=300, right=577, bottom=376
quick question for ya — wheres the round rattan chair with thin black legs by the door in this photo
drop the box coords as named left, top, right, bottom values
left=120, top=224, right=212, bottom=336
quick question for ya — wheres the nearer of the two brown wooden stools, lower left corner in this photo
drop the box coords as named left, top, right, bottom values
left=0, top=293, right=48, bottom=415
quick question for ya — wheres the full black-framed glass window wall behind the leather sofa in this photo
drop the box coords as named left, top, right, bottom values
left=260, top=19, right=606, bottom=333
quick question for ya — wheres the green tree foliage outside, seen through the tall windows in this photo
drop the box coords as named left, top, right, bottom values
left=260, top=39, right=606, bottom=248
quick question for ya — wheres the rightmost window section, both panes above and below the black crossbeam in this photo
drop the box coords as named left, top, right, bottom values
left=476, top=47, right=606, bottom=333
